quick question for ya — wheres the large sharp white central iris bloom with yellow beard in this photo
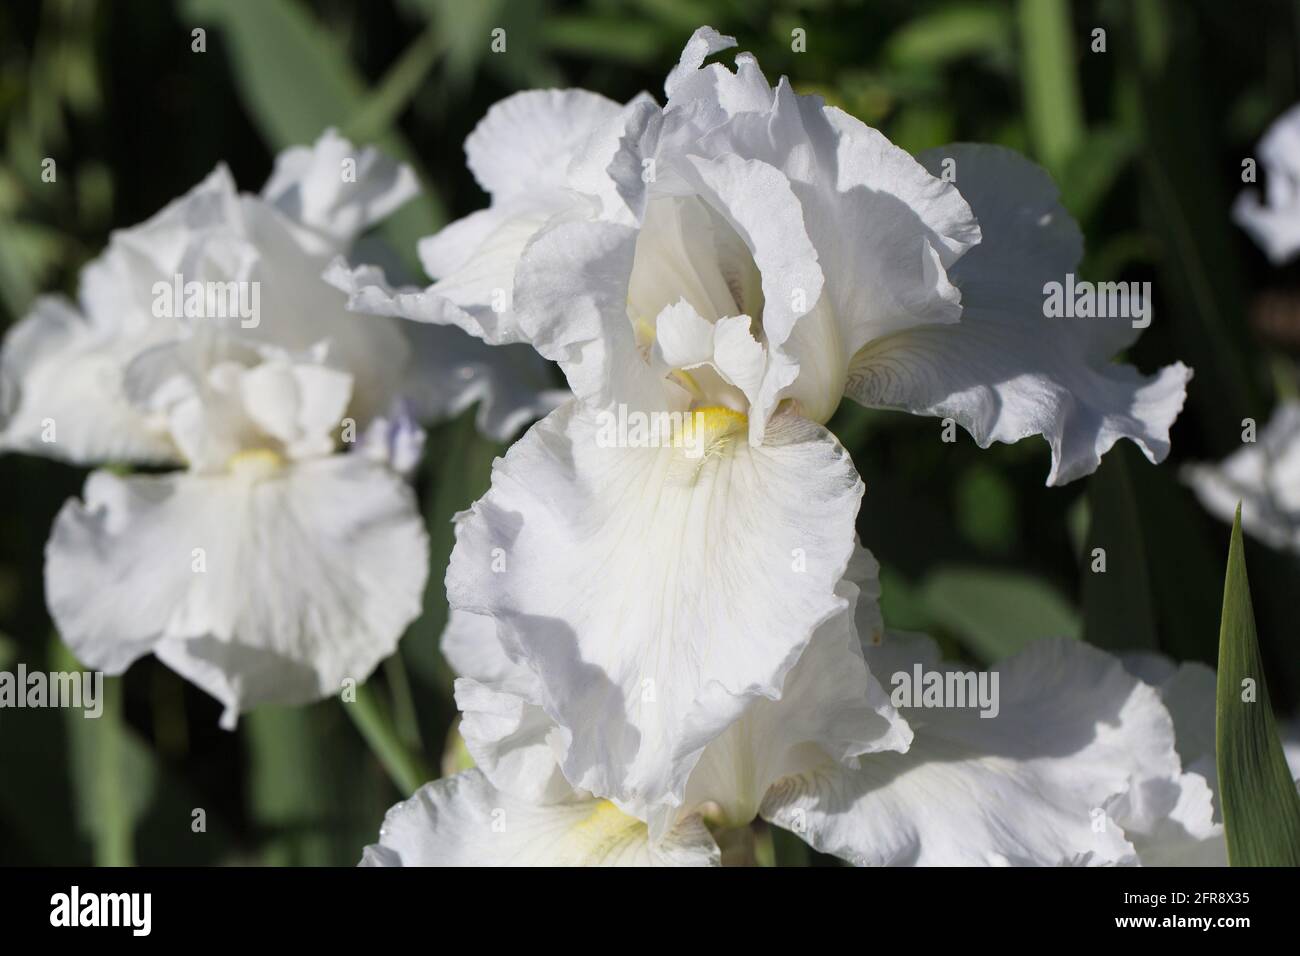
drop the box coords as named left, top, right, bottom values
left=332, top=27, right=1190, bottom=834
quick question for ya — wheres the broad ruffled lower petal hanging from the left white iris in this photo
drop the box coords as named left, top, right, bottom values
left=46, top=453, right=428, bottom=726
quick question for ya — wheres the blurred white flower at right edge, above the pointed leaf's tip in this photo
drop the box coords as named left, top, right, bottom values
left=1183, top=401, right=1300, bottom=551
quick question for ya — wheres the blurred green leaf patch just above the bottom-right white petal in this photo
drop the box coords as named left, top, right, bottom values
left=922, top=567, right=1080, bottom=661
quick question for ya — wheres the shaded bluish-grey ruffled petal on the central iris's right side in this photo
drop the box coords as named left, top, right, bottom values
left=848, top=146, right=1191, bottom=484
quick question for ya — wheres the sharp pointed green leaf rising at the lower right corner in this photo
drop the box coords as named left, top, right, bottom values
left=1216, top=505, right=1300, bottom=866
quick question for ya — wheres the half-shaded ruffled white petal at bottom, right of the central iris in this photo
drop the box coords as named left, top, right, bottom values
left=763, top=637, right=1178, bottom=866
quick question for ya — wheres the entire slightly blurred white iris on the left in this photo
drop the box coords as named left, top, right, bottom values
left=0, top=131, right=517, bottom=726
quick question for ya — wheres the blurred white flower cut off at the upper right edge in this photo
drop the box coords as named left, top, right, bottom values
left=1232, top=105, right=1300, bottom=265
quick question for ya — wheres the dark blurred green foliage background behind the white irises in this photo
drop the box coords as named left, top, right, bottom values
left=0, top=0, right=1300, bottom=864
